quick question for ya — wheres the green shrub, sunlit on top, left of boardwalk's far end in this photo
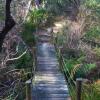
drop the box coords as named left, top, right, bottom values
left=21, top=8, right=48, bottom=46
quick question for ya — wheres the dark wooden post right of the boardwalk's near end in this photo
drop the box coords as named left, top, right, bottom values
left=76, top=78, right=83, bottom=100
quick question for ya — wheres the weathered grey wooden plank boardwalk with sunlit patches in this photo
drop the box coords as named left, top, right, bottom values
left=32, top=31, right=70, bottom=100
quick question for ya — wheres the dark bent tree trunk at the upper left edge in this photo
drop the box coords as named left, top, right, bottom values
left=0, top=0, right=16, bottom=51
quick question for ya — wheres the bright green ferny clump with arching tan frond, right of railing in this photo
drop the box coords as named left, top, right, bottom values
left=64, top=58, right=96, bottom=79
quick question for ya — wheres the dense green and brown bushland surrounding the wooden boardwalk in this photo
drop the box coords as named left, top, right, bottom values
left=0, top=0, right=100, bottom=100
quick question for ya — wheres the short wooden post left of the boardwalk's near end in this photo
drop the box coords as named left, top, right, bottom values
left=26, top=80, right=32, bottom=100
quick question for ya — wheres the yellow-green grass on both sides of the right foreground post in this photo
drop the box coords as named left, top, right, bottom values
left=69, top=83, right=100, bottom=100
